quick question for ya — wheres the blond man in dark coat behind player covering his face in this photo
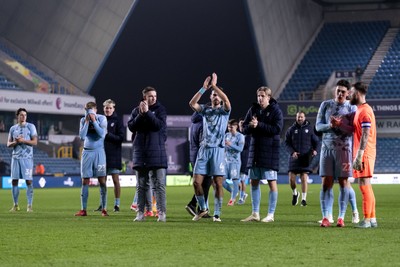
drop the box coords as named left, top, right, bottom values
left=96, top=99, right=124, bottom=212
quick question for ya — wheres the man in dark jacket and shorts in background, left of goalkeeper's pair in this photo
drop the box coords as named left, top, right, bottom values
left=285, top=111, right=319, bottom=206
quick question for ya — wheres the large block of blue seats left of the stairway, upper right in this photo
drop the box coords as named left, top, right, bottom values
left=279, top=21, right=390, bottom=100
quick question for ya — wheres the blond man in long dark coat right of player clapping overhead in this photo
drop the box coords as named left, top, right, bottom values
left=242, top=86, right=283, bottom=223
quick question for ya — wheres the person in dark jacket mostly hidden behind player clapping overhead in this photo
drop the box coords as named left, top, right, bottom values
left=185, top=112, right=212, bottom=218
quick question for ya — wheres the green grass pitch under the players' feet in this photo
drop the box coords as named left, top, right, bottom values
left=0, top=184, right=400, bottom=266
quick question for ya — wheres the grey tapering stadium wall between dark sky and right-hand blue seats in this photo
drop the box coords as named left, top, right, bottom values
left=246, top=0, right=323, bottom=96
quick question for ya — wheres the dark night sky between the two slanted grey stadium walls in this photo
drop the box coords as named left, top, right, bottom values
left=90, top=0, right=265, bottom=118
